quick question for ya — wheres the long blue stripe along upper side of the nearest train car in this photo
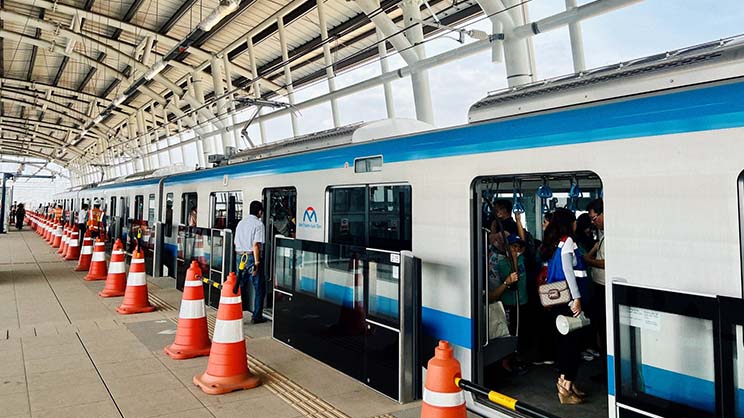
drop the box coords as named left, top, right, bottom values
left=165, top=83, right=744, bottom=184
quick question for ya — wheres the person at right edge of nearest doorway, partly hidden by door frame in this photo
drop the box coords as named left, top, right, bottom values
left=584, top=198, right=607, bottom=380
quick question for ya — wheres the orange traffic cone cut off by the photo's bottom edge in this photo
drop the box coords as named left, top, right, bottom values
left=421, top=341, right=467, bottom=418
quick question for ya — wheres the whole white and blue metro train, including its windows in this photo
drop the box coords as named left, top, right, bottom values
left=55, top=38, right=744, bottom=417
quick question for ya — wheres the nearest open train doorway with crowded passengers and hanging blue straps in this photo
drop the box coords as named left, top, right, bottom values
left=472, top=172, right=607, bottom=417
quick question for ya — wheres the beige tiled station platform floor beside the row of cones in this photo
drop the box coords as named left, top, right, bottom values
left=0, top=231, right=464, bottom=418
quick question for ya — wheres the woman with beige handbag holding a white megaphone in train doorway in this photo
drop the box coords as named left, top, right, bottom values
left=540, top=208, right=586, bottom=404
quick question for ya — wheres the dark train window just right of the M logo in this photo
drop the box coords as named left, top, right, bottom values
left=330, top=185, right=412, bottom=251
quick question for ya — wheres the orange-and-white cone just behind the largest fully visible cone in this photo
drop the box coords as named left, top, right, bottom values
left=164, top=261, right=212, bottom=360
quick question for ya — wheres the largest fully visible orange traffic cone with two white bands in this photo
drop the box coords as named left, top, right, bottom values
left=194, top=273, right=261, bottom=395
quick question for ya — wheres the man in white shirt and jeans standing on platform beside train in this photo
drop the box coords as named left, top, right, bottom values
left=233, top=200, right=266, bottom=324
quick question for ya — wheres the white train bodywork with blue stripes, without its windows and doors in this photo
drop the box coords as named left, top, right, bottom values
left=57, top=37, right=744, bottom=416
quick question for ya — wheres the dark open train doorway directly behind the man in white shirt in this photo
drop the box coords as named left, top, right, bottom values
left=263, top=187, right=297, bottom=316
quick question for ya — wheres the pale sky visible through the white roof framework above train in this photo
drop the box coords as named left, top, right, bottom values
left=244, top=0, right=744, bottom=141
